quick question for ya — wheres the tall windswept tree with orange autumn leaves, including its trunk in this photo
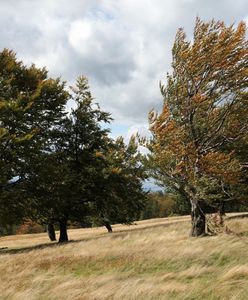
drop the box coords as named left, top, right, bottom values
left=149, top=19, right=248, bottom=236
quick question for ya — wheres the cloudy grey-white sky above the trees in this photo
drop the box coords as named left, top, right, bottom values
left=0, top=0, right=248, bottom=140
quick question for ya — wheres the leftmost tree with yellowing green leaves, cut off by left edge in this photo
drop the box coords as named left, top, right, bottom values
left=0, top=49, right=68, bottom=232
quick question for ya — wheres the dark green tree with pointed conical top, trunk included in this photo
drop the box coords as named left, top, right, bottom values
left=26, top=77, right=110, bottom=242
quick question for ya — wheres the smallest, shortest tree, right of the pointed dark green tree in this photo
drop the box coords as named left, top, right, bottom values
left=91, top=136, right=147, bottom=232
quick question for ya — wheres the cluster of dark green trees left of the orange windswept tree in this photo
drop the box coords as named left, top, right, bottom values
left=0, top=49, right=147, bottom=242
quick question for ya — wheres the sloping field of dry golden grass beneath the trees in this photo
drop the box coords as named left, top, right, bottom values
left=0, top=216, right=248, bottom=300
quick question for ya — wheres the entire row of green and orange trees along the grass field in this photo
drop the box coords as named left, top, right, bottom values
left=0, top=18, right=248, bottom=242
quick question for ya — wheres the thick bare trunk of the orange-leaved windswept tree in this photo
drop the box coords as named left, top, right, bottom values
left=190, top=201, right=206, bottom=237
